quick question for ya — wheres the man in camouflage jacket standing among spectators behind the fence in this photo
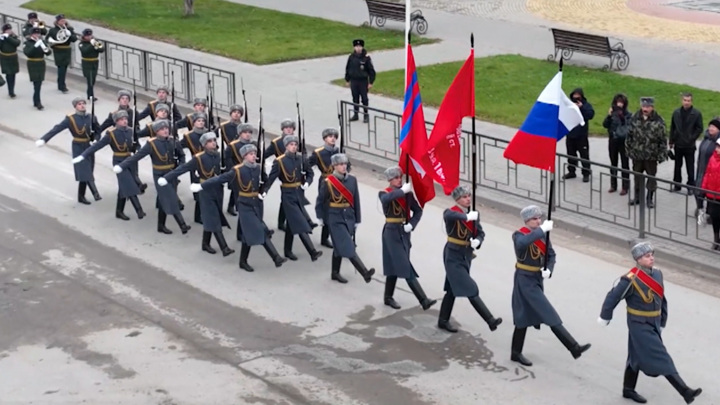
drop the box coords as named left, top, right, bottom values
left=625, top=97, right=668, bottom=208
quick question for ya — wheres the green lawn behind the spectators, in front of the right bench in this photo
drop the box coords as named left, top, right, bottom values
left=340, top=55, right=720, bottom=135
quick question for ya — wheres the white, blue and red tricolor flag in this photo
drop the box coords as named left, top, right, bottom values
left=503, top=65, right=585, bottom=173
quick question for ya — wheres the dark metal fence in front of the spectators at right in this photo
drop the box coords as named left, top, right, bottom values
left=338, top=101, right=713, bottom=249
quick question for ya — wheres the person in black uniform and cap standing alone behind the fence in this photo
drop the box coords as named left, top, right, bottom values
left=345, top=39, right=375, bottom=122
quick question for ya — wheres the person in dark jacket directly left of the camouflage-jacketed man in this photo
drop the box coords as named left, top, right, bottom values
left=603, top=94, right=632, bottom=195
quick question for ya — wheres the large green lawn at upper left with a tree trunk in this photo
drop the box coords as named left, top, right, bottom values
left=23, top=0, right=437, bottom=65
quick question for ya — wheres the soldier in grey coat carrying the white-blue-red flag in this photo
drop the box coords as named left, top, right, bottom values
left=510, top=205, right=590, bottom=366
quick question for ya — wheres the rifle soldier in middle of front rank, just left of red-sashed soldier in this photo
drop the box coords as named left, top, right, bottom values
left=263, top=135, right=322, bottom=261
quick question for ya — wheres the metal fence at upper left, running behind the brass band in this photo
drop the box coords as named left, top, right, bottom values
left=0, top=14, right=235, bottom=112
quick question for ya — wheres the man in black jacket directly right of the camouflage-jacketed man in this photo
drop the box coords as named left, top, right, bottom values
left=670, top=93, right=703, bottom=194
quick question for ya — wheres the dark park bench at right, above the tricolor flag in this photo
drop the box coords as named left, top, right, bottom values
left=548, top=28, right=630, bottom=70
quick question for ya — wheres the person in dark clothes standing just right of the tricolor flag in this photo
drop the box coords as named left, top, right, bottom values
left=563, top=87, right=595, bottom=183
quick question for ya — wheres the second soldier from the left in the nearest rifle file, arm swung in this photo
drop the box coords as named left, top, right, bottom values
left=73, top=110, right=145, bottom=221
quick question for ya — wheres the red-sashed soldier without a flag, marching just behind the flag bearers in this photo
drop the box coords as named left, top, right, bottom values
left=315, top=153, right=375, bottom=284
